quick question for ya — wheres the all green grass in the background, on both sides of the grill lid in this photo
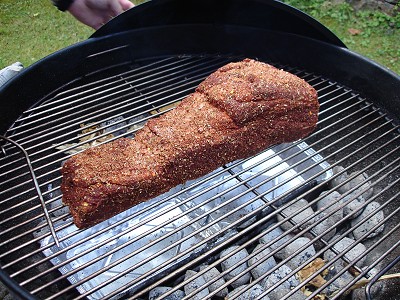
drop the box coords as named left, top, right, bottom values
left=0, top=0, right=400, bottom=74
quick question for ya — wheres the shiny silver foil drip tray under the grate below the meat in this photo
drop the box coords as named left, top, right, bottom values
left=37, top=142, right=332, bottom=299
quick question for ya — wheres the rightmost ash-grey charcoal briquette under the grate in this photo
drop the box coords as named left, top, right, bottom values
left=351, top=202, right=385, bottom=239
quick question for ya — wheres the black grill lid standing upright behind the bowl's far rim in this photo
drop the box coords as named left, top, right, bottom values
left=92, top=0, right=346, bottom=47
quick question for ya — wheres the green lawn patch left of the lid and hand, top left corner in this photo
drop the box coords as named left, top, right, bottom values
left=0, top=0, right=93, bottom=68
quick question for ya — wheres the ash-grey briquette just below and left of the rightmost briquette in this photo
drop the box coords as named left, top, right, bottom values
left=324, top=237, right=367, bottom=271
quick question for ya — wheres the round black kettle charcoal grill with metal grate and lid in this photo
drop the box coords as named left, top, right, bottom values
left=0, top=0, right=400, bottom=299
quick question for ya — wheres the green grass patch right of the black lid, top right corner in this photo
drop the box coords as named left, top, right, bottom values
left=284, top=0, right=400, bottom=74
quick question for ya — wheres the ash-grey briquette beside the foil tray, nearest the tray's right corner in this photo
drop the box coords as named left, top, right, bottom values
left=278, top=199, right=314, bottom=230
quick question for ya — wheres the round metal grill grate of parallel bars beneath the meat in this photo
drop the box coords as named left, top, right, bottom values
left=0, top=56, right=400, bottom=299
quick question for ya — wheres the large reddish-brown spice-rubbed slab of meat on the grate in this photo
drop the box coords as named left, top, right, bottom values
left=61, top=59, right=319, bottom=228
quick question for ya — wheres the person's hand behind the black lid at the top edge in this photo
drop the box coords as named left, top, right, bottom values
left=68, top=0, right=134, bottom=30
